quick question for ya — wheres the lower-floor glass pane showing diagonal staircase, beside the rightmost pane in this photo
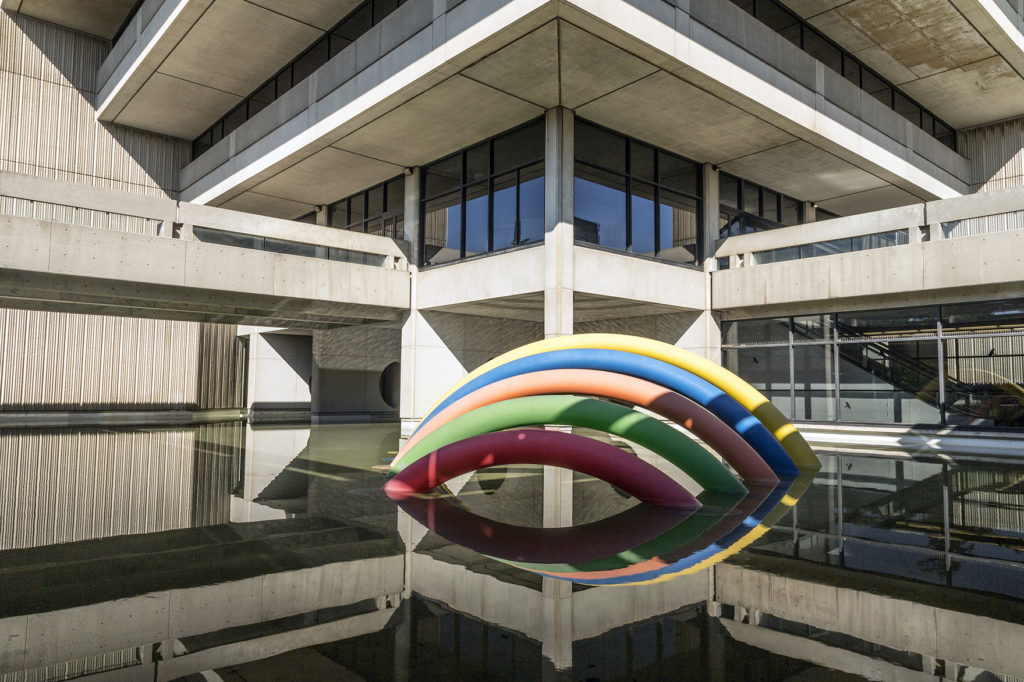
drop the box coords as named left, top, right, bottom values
left=839, top=339, right=940, bottom=424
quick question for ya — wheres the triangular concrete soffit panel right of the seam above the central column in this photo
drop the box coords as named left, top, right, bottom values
left=558, top=22, right=657, bottom=109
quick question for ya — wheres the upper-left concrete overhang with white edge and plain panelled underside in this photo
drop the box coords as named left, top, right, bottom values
left=96, top=0, right=359, bottom=139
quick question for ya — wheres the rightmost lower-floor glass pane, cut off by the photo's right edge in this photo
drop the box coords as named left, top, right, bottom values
left=942, top=336, right=1024, bottom=427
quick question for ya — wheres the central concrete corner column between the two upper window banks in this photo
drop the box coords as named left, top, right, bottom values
left=544, top=108, right=574, bottom=338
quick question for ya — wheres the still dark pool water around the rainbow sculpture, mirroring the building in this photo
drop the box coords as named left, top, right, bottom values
left=0, top=423, right=1024, bottom=682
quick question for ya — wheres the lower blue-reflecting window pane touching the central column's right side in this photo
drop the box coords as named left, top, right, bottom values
left=573, top=164, right=626, bottom=250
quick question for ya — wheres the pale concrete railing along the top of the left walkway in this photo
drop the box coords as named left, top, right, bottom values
left=0, top=172, right=409, bottom=270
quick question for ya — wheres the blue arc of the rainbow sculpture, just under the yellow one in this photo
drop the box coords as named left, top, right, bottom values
left=414, top=348, right=800, bottom=479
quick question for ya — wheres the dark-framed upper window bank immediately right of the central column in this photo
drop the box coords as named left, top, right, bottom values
left=573, top=119, right=702, bottom=265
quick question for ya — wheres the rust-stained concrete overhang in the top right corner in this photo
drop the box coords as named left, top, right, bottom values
left=785, top=0, right=1024, bottom=129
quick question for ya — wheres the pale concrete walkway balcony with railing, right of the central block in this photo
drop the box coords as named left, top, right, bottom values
left=712, top=184, right=1024, bottom=316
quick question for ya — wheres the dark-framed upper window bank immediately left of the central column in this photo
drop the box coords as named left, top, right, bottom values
left=420, top=120, right=544, bottom=265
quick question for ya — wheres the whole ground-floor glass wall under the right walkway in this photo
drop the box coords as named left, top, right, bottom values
left=722, top=299, right=1024, bottom=428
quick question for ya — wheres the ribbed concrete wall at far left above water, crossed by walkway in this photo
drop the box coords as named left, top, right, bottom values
left=0, top=12, right=244, bottom=412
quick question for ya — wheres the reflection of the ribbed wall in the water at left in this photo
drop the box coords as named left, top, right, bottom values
left=0, top=423, right=244, bottom=551
